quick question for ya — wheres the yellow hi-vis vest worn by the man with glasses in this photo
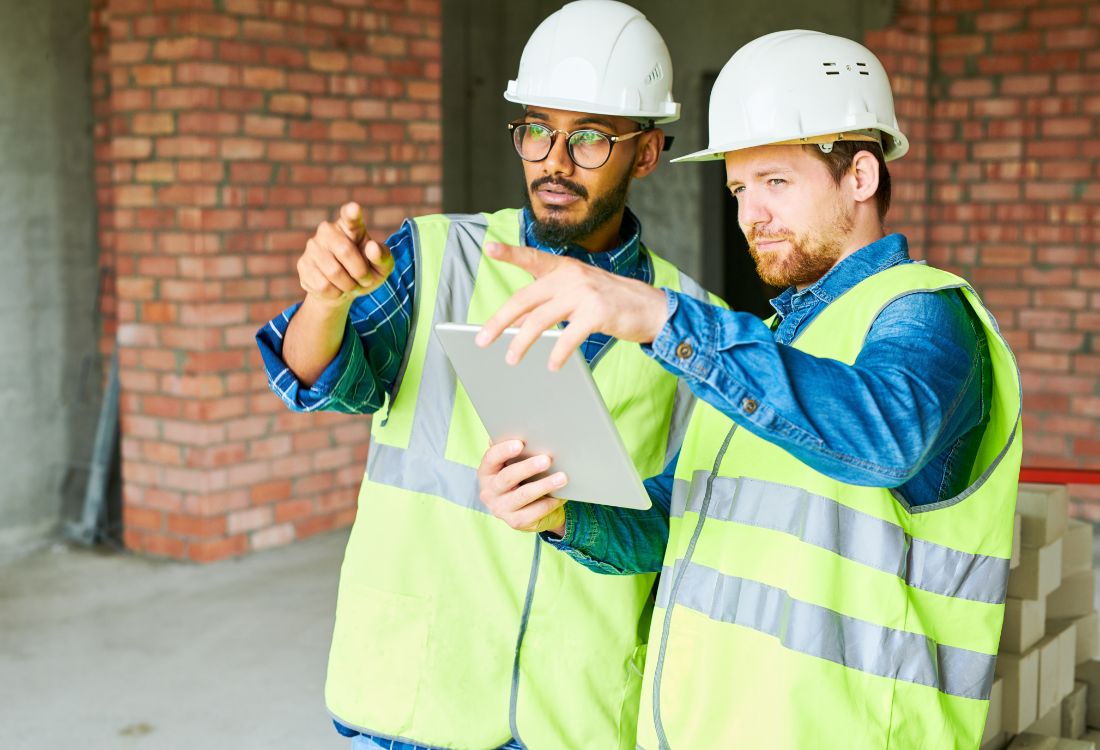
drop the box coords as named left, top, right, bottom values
left=326, top=210, right=704, bottom=750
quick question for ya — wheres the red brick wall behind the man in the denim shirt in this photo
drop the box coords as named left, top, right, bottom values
left=867, top=0, right=1100, bottom=520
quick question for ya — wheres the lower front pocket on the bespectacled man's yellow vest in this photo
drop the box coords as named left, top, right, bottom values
left=327, top=584, right=432, bottom=736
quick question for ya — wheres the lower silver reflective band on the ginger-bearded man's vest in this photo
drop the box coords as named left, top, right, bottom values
left=657, top=561, right=997, bottom=701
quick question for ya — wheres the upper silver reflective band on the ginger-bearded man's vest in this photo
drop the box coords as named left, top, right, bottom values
left=672, top=471, right=1009, bottom=604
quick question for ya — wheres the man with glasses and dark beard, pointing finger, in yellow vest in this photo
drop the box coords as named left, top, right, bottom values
left=257, top=0, right=704, bottom=750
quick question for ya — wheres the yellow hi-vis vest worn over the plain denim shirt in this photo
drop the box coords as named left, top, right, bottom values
left=638, top=264, right=1021, bottom=750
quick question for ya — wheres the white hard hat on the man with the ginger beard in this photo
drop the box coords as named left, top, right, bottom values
left=672, top=30, right=909, bottom=162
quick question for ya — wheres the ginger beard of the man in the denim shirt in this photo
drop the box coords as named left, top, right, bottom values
left=745, top=192, right=855, bottom=289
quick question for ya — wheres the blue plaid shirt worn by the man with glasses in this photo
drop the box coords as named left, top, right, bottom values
left=256, top=209, right=653, bottom=750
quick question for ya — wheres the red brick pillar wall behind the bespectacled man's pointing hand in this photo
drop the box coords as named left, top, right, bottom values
left=92, top=0, right=442, bottom=561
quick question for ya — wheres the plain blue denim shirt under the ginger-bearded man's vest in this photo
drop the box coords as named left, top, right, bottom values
left=554, top=234, right=992, bottom=573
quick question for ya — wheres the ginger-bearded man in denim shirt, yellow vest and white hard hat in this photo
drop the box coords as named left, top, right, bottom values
left=480, top=31, right=1021, bottom=750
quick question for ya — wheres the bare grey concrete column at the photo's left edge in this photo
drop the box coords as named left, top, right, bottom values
left=0, top=0, right=100, bottom=551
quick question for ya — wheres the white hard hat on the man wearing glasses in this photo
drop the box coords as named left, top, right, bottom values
left=504, top=0, right=680, bottom=123
